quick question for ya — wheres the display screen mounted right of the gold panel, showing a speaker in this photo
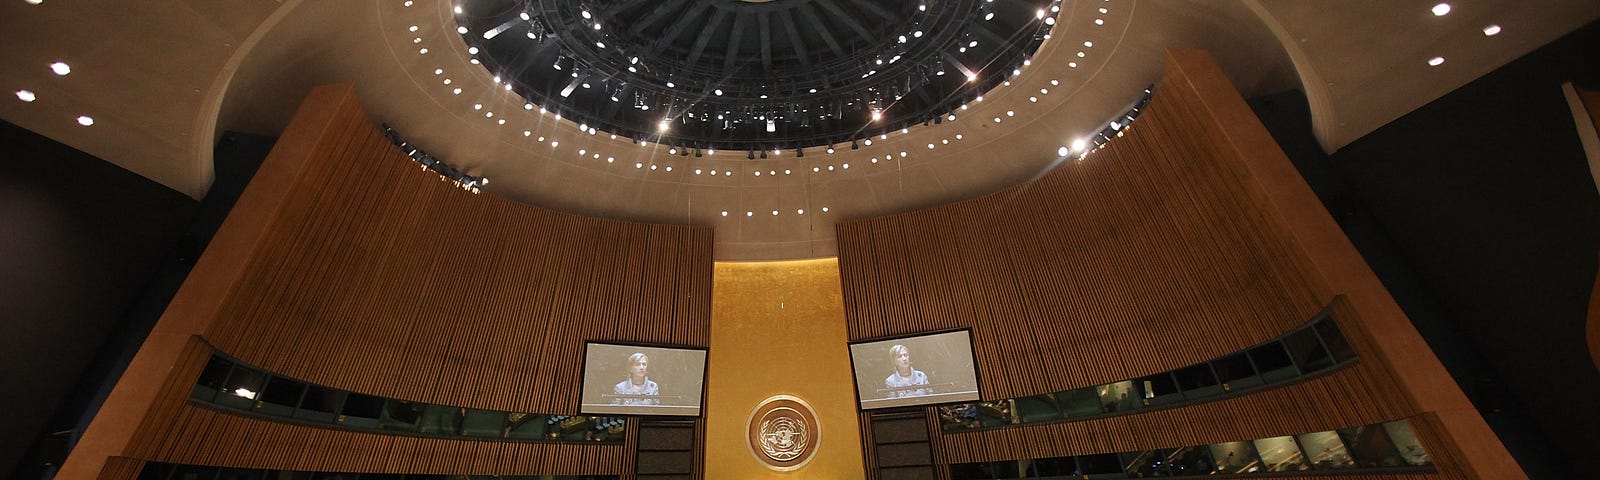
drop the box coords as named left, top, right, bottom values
left=850, top=330, right=979, bottom=410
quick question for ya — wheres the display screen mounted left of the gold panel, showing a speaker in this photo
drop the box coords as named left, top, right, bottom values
left=578, top=342, right=706, bottom=416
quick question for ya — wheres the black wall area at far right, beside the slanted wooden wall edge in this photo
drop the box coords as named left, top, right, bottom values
left=1251, top=19, right=1600, bottom=478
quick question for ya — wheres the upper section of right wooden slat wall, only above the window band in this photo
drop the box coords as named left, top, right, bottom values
left=838, top=52, right=1328, bottom=398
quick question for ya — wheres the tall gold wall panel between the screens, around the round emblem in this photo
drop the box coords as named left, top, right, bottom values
left=706, top=259, right=866, bottom=480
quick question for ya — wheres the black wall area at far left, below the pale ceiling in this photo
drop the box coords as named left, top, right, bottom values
left=0, top=122, right=197, bottom=472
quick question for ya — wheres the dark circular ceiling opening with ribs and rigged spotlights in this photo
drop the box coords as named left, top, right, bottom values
left=456, top=0, right=1059, bottom=155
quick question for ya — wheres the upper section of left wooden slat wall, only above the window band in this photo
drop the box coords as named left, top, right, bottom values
left=193, top=84, right=712, bottom=413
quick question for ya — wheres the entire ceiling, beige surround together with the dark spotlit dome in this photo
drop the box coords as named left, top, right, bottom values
left=0, top=0, right=1600, bottom=261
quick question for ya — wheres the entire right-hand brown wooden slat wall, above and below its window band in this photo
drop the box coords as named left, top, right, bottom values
left=838, top=50, right=1464, bottom=478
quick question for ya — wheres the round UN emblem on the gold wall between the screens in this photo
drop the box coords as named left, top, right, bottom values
left=749, top=395, right=822, bottom=472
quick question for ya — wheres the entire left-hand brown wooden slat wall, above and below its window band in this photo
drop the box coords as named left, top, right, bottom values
left=109, top=85, right=712, bottom=477
